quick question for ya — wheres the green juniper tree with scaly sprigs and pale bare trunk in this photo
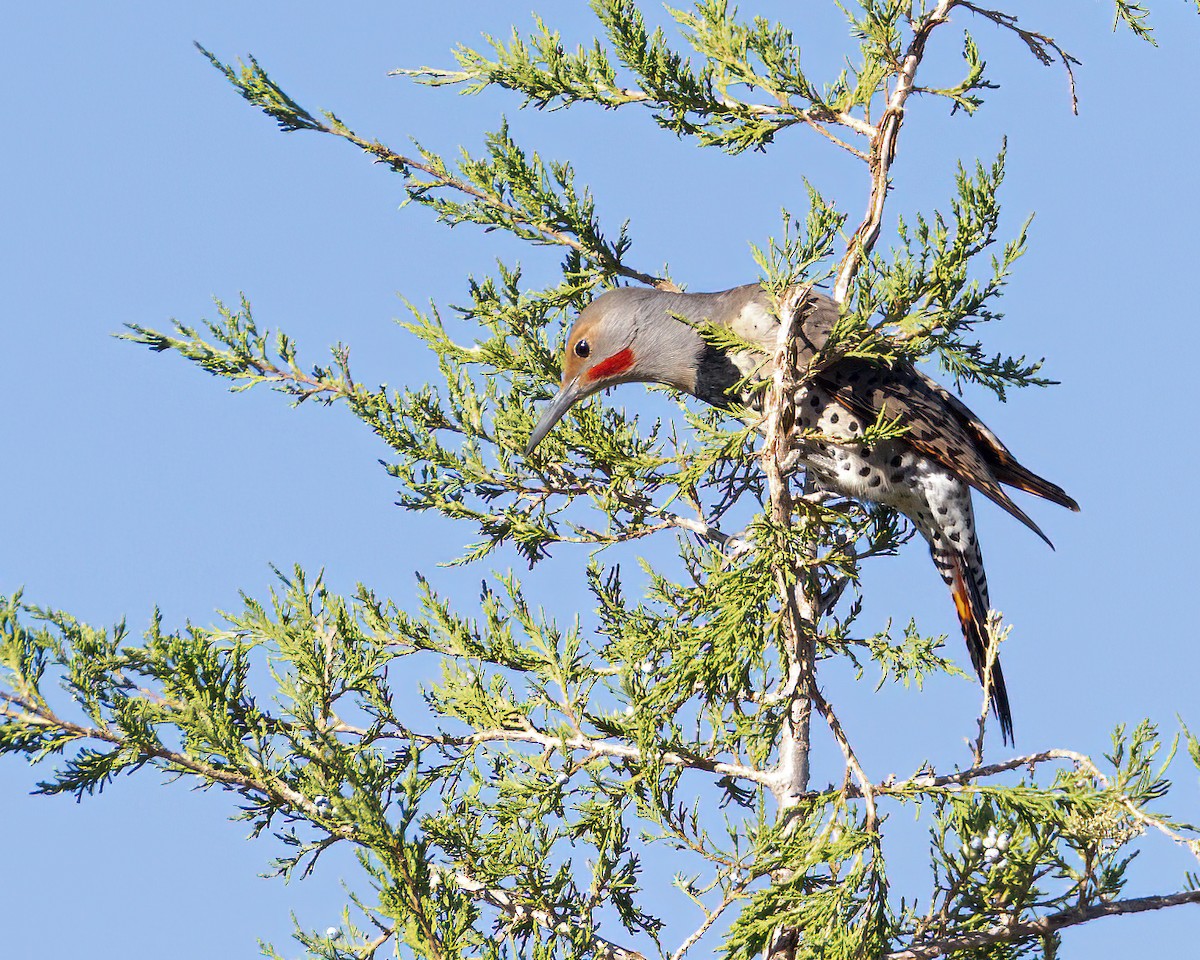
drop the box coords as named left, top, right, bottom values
left=0, top=0, right=1200, bottom=960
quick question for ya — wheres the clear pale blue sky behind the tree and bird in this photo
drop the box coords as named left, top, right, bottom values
left=0, top=0, right=1200, bottom=960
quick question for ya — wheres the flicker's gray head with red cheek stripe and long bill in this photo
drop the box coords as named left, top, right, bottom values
left=526, top=287, right=704, bottom=455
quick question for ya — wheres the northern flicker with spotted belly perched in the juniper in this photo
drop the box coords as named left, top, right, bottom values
left=526, top=283, right=1079, bottom=744
